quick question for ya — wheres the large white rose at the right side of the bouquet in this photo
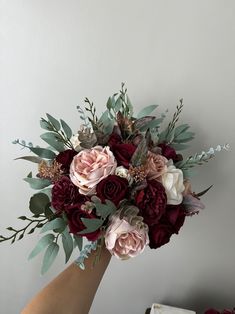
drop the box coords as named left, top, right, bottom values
left=161, top=165, right=185, bottom=205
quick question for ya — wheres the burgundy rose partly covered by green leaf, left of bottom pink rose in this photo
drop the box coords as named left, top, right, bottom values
left=67, top=204, right=100, bottom=241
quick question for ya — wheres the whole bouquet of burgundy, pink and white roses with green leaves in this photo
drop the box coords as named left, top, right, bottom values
left=0, top=84, right=228, bottom=274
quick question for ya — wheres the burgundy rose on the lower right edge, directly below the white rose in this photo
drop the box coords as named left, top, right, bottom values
left=160, top=204, right=185, bottom=233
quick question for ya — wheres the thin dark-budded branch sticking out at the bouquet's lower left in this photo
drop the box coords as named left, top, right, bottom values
left=0, top=215, right=48, bottom=243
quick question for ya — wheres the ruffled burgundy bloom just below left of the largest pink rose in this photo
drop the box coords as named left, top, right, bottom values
left=51, top=176, right=88, bottom=212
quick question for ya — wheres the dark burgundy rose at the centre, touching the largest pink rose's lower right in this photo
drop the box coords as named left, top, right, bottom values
left=96, top=175, right=128, bottom=206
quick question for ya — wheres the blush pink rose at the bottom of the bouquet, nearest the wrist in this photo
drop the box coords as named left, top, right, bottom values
left=105, top=217, right=149, bottom=260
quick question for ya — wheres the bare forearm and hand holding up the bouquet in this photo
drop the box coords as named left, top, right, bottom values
left=21, top=247, right=111, bottom=314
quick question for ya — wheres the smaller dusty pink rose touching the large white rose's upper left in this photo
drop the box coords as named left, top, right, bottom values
left=146, top=152, right=168, bottom=180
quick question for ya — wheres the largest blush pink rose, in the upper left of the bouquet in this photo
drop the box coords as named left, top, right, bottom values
left=70, top=146, right=117, bottom=195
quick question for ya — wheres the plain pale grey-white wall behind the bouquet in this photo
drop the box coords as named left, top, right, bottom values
left=0, top=0, right=235, bottom=314
